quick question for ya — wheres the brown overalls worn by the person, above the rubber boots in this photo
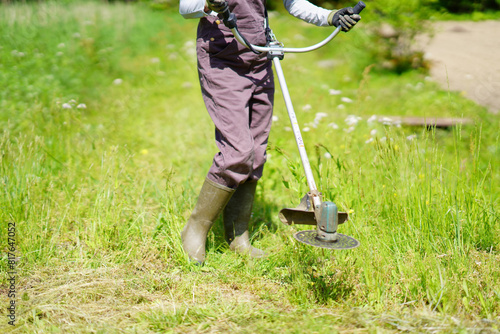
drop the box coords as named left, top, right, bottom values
left=197, top=0, right=274, bottom=188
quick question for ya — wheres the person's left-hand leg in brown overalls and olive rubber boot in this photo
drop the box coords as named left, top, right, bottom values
left=182, top=48, right=254, bottom=263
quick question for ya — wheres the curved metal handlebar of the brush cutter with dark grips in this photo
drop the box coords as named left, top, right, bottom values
left=219, top=1, right=366, bottom=53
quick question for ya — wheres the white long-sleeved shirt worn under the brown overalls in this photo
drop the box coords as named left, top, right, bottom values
left=179, top=0, right=332, bottom=27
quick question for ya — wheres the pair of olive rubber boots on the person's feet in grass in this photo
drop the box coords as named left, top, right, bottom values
left=181, top=178, right=266, bottom=264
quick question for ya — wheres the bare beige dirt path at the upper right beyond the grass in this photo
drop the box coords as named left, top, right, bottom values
left=425, top=21, right=500, bottom=113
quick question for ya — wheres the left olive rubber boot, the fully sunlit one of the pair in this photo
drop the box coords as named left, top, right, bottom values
left=181, top=178, right=234, bottom=265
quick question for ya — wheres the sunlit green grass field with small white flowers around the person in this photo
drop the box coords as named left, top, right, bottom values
left=0, top=2, right=500, bottom=333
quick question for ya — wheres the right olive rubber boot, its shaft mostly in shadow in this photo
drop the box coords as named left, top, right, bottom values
left=223, top=182, right=266, bottom=258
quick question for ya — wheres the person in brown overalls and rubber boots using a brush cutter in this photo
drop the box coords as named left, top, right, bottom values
left=179, top=0, right=361, bottom=264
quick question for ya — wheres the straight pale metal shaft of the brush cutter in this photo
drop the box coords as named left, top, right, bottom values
left=273, top=57, right=317, bottom=194
